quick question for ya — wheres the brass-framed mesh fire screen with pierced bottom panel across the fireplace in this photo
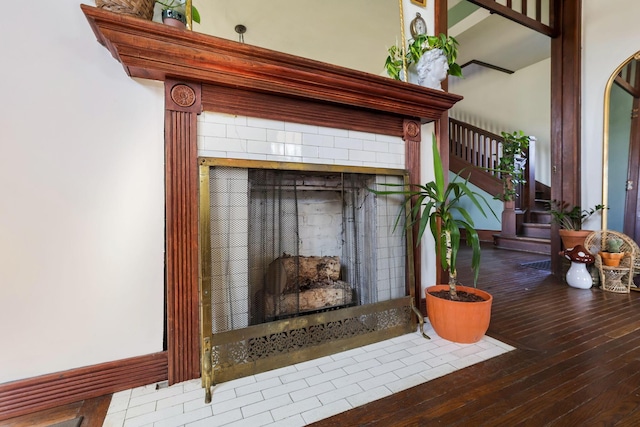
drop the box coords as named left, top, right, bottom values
left=200, top=159, right=416, bottom=402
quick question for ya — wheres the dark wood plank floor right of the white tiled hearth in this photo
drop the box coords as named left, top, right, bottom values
left=314, top=246, right=640, bottom=427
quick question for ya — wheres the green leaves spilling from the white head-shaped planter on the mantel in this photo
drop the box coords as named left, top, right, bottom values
left=384, top=34, right=462, bottom=80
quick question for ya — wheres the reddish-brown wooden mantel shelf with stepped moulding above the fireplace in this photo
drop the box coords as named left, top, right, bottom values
left=80, top=4, right=462, bottom=122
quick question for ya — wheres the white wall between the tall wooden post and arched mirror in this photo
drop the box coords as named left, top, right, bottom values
left=581, top=0, right=640, bottom=229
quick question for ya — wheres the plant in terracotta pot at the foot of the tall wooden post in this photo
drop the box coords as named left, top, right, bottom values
left=549, top=200, right=606, bottom=249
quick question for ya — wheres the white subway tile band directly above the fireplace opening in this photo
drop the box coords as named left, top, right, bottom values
left=198, top=111, right=405, bottom=169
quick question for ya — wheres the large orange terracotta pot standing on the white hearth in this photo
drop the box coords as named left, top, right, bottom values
left=425, top=285, right=493, bottom=344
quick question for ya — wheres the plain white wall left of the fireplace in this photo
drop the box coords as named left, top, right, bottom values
left=0, top=0, right=164, bottom=383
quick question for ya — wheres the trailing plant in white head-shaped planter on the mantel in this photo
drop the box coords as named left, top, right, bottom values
left=384, top=34, right=462, bottom=89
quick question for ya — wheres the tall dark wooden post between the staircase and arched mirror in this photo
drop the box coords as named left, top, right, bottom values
left=551, top=0, right=582, bottom=276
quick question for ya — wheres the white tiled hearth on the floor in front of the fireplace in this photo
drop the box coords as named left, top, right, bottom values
left=104, top=322, right=513, bottom=427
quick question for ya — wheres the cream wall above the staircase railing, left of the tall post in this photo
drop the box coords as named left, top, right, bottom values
left=449, top=59, right=551, bottom=185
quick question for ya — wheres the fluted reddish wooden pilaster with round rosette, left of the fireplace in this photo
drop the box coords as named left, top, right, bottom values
left=164, top=79, right=202, bottom=384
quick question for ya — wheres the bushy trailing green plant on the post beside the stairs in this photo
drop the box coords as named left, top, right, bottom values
left=497, top=130, right=531, bottom=202
